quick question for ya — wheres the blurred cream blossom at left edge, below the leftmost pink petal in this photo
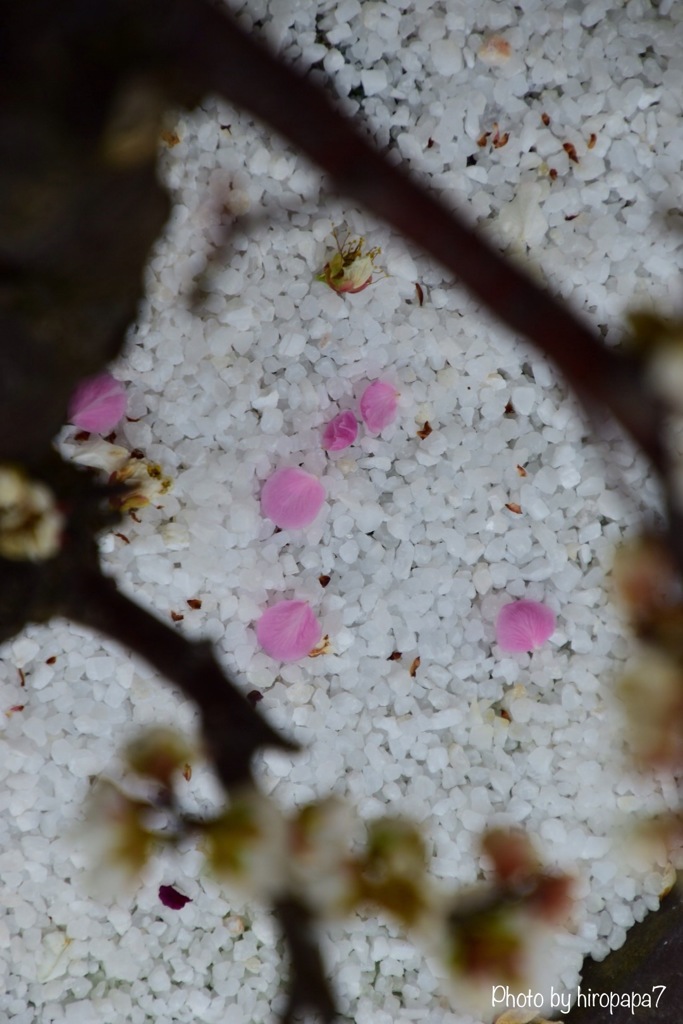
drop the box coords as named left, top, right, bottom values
left=0, top=464, right=63, bottom=562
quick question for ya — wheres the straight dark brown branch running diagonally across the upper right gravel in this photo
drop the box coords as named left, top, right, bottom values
left=154, top=0, right=667, bottom=472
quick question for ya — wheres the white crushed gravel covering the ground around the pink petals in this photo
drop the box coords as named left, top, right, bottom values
left=0, top=0, right=683, bottom=1024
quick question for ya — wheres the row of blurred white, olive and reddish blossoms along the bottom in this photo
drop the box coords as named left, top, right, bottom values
left=78, top=729, right=571, bottom=1020
